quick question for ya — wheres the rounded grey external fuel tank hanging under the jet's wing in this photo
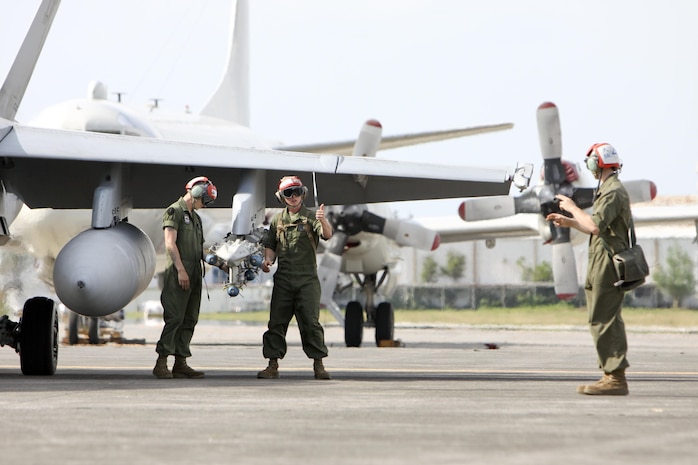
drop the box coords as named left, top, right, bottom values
left=53, top=222, right=155, bottom=317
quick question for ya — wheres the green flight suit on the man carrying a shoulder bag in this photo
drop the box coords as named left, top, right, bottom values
left=584, top=174, right=631, bottom=373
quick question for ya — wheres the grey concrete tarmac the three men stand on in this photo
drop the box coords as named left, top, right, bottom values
left=0, top=322, right=698, bottom=465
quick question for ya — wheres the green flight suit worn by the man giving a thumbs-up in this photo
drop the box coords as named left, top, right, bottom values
left=262, top=205, right=327, bottom=359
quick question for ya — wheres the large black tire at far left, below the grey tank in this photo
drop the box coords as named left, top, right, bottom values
left=19, top=297, right=58, bottom=375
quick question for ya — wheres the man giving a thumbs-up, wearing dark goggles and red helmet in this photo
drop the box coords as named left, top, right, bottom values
left=257, top=176, right=332, bottom=379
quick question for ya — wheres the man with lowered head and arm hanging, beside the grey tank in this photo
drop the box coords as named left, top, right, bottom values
left=153, top=176, right=218, bottom=379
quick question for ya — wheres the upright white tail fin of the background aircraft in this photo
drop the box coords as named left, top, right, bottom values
left=201, top=0, right=250, bottom=127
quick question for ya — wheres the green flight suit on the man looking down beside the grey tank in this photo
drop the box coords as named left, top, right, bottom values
left=156, top=197, right=204, bottom=357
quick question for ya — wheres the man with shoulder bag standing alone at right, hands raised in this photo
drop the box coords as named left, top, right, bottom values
left=546, top=143, right=632, bottom=396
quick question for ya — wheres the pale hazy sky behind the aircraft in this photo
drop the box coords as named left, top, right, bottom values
left=0, top=0, right=698, bottom=216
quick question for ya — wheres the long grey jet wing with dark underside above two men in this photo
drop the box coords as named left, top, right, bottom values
left=0, top=120, right=511, bottom=208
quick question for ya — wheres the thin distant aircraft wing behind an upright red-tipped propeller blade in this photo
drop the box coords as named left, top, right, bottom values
left=276, top=123, right=514, bottom=155
